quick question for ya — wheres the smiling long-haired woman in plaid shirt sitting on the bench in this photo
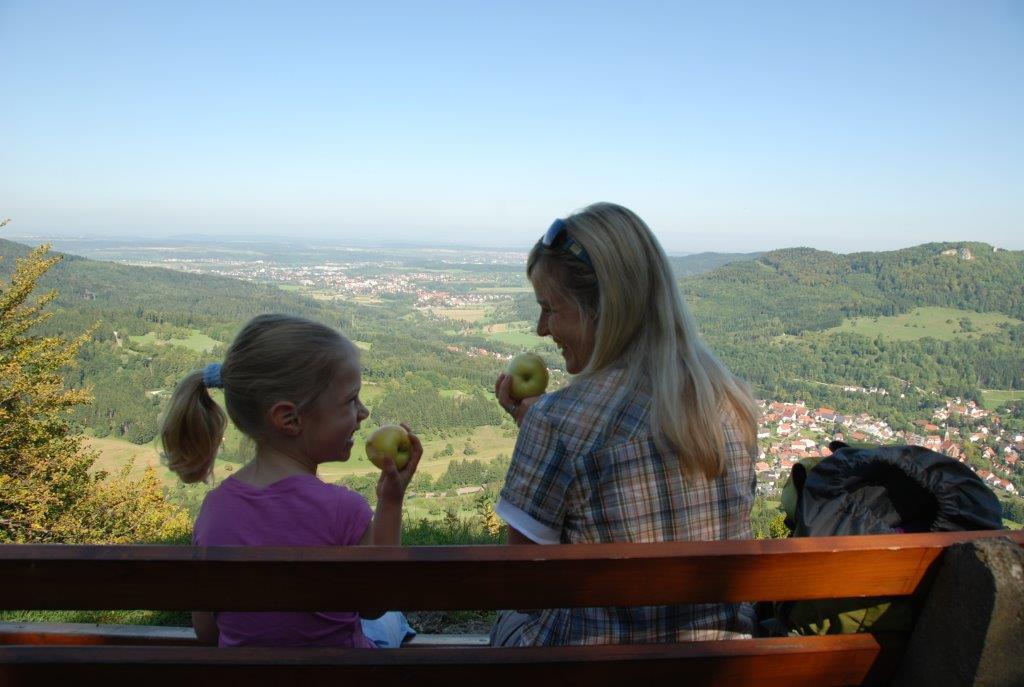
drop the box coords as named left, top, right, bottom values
left=492, top=203, right=757, bottom=645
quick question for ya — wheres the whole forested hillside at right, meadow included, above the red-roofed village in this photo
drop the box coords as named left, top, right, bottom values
left=680, top=243, right=1024, bottom=424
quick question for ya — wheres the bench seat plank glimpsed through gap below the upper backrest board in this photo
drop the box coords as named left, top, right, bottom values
left=0, top=622, right=488, bottom=648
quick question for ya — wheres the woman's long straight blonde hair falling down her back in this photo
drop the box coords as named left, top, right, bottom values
left=526, top=203, right=758, bottom=479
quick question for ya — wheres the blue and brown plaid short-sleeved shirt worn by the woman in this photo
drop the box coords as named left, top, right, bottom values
left=496, top=370, right=755, bottom=645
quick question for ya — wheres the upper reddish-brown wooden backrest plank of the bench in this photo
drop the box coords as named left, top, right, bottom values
left=0, top=530, right=1024, bottom=610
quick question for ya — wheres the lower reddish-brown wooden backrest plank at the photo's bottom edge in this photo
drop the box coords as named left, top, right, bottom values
left=0, top=635, right=903, bottom=687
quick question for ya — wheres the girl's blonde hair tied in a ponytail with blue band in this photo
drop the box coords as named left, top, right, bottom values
left=160, top=314, right=358, bottom=482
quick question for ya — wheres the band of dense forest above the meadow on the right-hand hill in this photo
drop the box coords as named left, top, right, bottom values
left=680, top=243, right=1024, bottom=335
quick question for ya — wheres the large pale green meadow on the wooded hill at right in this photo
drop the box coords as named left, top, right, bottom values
left=824, top=307, right=1021, bottom=341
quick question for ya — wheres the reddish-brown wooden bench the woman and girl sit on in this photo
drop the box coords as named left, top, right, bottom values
left=0, top=531, right=1024, bottom=687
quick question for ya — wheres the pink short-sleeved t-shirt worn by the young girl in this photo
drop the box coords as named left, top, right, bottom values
left=193, top=475, right=374, bottom=648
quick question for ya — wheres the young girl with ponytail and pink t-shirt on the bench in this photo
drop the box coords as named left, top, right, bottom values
left=161, top=314, right=423, bottom=647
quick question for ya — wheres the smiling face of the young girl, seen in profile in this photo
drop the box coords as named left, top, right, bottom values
left=302, top=355, right=370, bottom=464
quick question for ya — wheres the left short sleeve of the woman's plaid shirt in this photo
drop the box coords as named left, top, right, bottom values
left=495, top=409, right=572, bottom=544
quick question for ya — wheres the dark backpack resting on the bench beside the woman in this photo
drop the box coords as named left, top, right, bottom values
left=765, top=441, right=1002, bottom=635
